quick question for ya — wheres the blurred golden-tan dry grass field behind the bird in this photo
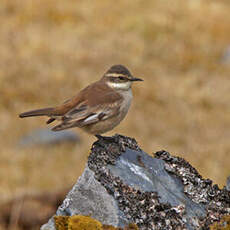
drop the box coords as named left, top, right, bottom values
left=0, top=0, right=230, bottom=229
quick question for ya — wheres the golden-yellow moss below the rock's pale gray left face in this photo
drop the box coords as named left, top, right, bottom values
left=54, top=215, right=139, bottom=230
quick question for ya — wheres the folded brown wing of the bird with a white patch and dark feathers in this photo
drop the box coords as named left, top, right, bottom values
left=53, top=84, right=123, bottom=131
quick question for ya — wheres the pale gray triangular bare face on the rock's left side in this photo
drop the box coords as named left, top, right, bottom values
left=41, top=166, right=127, bottom=230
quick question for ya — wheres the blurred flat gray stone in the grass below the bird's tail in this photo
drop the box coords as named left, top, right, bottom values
left=18, top=129, right=80, bottom=147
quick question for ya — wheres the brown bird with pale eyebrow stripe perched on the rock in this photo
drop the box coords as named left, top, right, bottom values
left=19, top=65, right=143, bottom=138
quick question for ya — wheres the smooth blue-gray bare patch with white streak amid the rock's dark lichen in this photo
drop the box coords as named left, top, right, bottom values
left=108, top=148, right=206, bottom=229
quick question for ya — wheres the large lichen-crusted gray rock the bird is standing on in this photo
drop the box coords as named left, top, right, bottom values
left=41, top=135, right=230, bottom=230
